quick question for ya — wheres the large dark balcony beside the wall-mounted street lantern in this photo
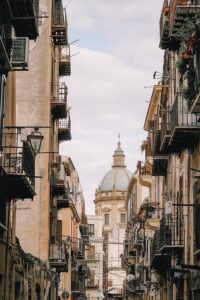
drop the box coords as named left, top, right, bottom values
left=0, top=129, right=35, bottom=200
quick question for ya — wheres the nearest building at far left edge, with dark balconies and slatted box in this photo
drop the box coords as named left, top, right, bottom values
left=0, top=0, right=49, bottom=299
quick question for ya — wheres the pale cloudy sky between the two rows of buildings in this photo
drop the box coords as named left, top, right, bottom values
left=60, top=0, right=164, bottom=214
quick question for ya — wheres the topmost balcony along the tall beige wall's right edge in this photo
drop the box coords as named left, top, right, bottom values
left=51, top=0, right=68, bottom=46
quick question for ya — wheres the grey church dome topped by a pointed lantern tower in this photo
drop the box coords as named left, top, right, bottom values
left=99, top=142, right=132, bottom=192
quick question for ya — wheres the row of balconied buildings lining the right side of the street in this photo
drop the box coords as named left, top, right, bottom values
left=122, top=0, right=200, bottom=300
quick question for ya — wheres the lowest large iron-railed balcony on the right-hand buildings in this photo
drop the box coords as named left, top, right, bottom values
left=160, top=216, right=184, bottom=253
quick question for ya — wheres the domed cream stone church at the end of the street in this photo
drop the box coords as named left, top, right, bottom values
left=94, top=142, right=131, bottom=299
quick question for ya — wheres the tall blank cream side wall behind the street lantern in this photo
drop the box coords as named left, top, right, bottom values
left=17, top=0, right=52, bottom=260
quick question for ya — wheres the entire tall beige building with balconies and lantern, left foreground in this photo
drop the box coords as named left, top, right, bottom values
left=0, top=0, right=74, bottom=299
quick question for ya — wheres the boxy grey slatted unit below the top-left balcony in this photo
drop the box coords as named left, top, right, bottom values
left=10, top=37, right=29, bottom=71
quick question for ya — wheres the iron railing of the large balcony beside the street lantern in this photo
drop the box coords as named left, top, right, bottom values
left=1, top=130, right=35, bottom=188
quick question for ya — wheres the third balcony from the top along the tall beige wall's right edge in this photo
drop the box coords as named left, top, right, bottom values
left=51, top=83, right=68, bottom=119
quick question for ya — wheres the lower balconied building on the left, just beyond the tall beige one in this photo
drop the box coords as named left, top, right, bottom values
left=56, top=156, right=89, bottom=300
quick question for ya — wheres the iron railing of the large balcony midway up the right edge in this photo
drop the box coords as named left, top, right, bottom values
left=170, top=93, right=199, bottom=133
